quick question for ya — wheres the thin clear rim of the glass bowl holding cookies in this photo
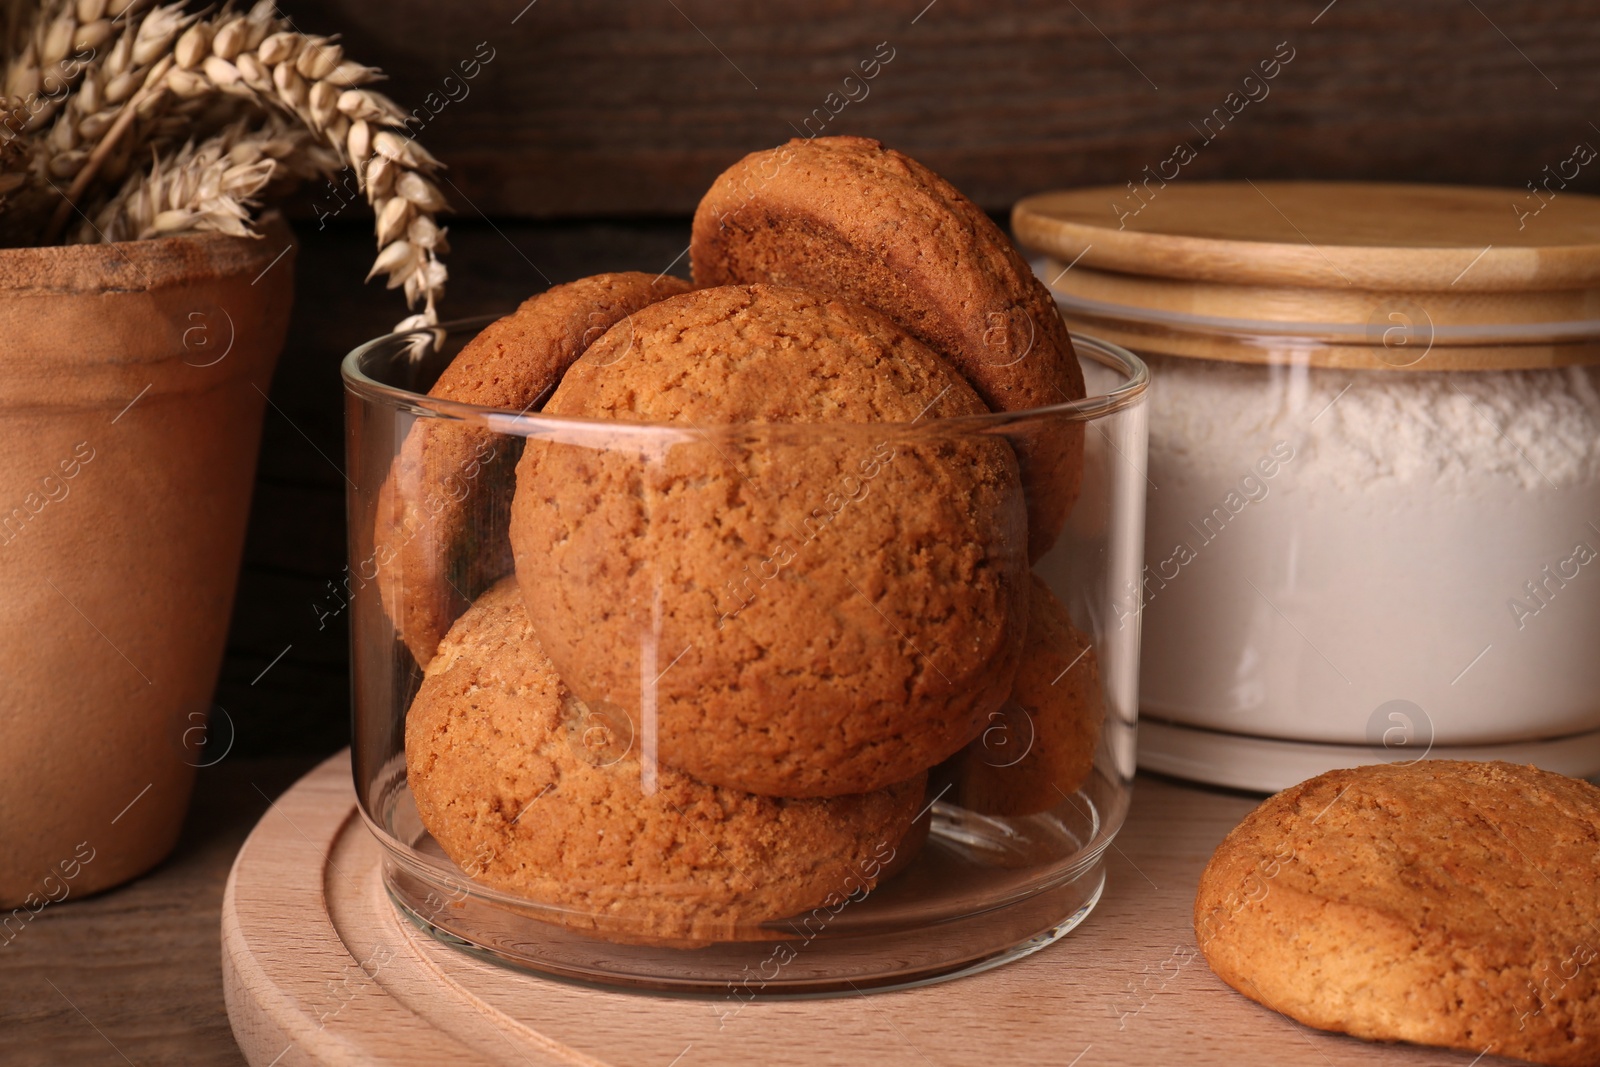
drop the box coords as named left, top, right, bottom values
left=339, top=312, right=1150, bottom=437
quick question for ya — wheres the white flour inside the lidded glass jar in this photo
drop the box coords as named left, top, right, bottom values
left=1141, top=357, right=1600, bottom=745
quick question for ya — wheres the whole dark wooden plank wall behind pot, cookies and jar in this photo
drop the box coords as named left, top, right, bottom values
left=213, top=0, right=1600, bottom=755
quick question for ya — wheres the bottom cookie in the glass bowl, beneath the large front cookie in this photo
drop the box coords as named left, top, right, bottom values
left=406, top=577, right=925, bottom=944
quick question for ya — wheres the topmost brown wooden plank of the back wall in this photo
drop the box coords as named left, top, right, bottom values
left=283, top=0, right=1600, bottom=218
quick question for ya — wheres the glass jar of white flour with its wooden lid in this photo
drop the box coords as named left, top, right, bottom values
left=1013, top=179, right=1600, bottom=790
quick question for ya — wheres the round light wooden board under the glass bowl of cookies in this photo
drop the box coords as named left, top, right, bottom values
left=222, top=752, right=1498, bottom=1067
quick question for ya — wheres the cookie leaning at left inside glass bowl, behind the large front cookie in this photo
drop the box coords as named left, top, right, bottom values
left=371, top=272, right=690, bottom=665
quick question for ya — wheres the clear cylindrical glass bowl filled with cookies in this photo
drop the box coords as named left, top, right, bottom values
left=342, top=318, right=1147, bottom=1011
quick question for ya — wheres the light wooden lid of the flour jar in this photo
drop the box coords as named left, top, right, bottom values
left=1013, top=180, right=1600, bottom=370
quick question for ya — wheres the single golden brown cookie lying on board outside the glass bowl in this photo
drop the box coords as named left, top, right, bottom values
left=1195, top=760, right=1600, bottom=1067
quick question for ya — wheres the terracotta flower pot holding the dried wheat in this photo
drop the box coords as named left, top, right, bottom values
left=0, top=219, right=294, bottom=908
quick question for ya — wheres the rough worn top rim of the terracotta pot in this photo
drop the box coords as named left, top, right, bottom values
left=0, top=211, right=296, bottom=293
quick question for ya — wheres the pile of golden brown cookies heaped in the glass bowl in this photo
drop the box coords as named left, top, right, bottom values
left=374, top=138, right=1101, bottom=944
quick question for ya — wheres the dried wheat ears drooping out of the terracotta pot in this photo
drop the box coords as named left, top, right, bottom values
left=0, top=0, right=448, bottom=330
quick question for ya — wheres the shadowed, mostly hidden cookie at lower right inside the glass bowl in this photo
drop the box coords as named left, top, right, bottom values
left=954, top=574, right=1106, bottom=816
